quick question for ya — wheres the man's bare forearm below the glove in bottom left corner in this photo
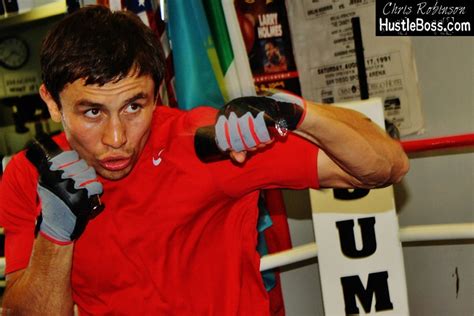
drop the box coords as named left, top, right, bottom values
left=3, top=235, right=73, bottom=315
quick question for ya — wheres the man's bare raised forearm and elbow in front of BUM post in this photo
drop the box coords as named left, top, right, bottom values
left=295, top=102, right=408, bottom=188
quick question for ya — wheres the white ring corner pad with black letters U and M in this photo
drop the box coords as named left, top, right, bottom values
left=310, top=98, right=409, bottom=316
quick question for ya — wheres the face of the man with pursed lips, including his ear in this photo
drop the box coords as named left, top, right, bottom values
left=42, top=72, right=155, bottom=180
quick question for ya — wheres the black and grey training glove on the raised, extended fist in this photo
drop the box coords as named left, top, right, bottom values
left=194, top=90, right=306, bottom=162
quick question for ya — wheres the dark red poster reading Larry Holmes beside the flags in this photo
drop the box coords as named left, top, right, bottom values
left=234, top=0, right=301, bottom=95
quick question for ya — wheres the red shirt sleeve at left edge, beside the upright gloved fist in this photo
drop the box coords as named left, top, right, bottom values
left=0, top=151, right=39, bottom=274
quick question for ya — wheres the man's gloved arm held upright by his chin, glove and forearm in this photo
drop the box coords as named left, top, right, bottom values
left=3, top=139, right=103, bottom=315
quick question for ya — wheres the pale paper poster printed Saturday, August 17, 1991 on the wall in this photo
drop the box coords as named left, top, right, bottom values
left=286, top=0, right=423, bottom=136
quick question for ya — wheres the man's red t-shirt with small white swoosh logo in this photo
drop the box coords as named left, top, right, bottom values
left=0, top=107, right=318, bottom=316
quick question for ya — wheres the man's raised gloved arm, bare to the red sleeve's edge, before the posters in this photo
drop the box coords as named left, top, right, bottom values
left=208, top=93, right=409, bottom=188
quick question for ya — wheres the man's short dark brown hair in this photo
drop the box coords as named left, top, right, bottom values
left=40, top=6, right=165, bottom=105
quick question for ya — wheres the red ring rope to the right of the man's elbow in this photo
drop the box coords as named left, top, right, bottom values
left=401, top=133, right=474, bottom=153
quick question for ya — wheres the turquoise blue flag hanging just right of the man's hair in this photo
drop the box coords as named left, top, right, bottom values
left=167, top=0, right=227, bottom=109
